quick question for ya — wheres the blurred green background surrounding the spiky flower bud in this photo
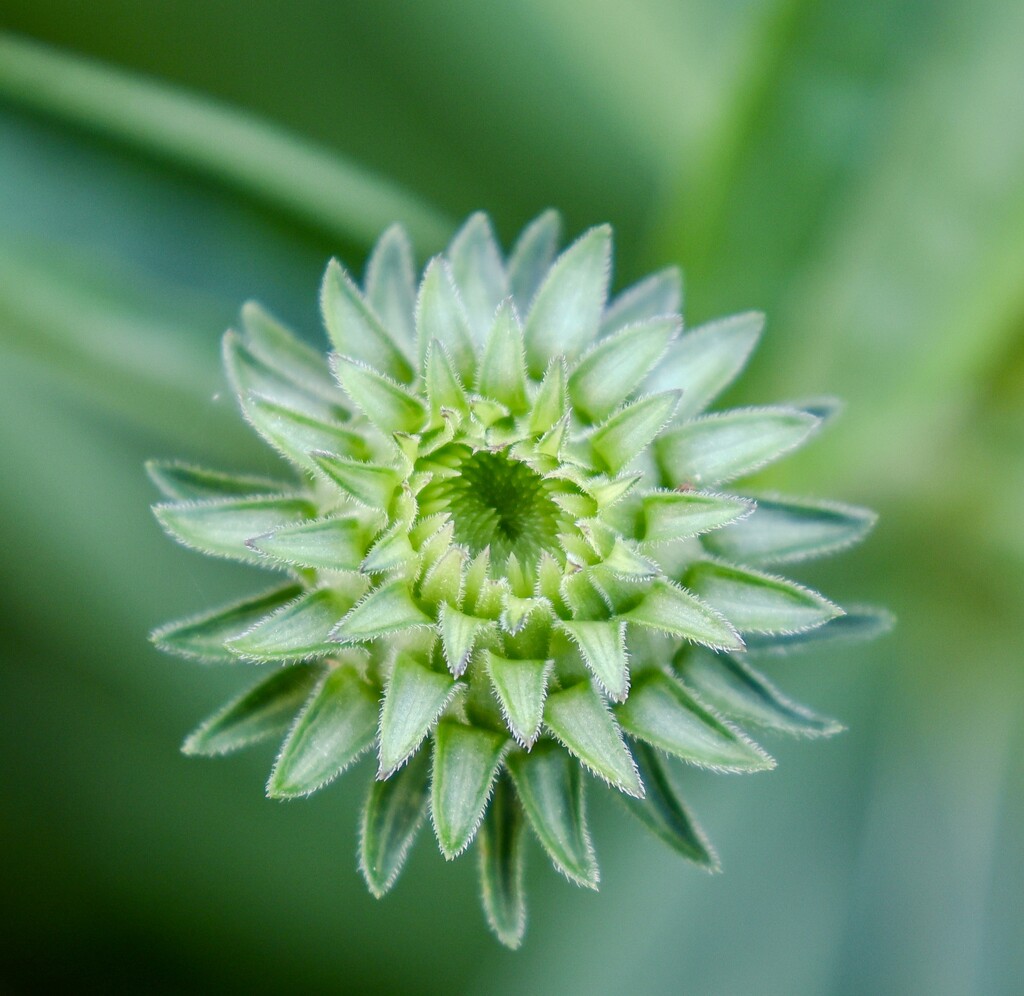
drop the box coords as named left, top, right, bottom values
left=0, top=0, right=1024, bottom=996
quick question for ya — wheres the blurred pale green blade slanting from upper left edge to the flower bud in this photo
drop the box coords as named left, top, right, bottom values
left=0, top=34, right=452, bottom=251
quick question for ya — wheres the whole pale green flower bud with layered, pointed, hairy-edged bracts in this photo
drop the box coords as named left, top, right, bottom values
left=148, top=212, right=884, bottom=947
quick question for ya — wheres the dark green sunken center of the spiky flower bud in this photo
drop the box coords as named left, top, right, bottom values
left=432, top=450, right=562, bottom=566
